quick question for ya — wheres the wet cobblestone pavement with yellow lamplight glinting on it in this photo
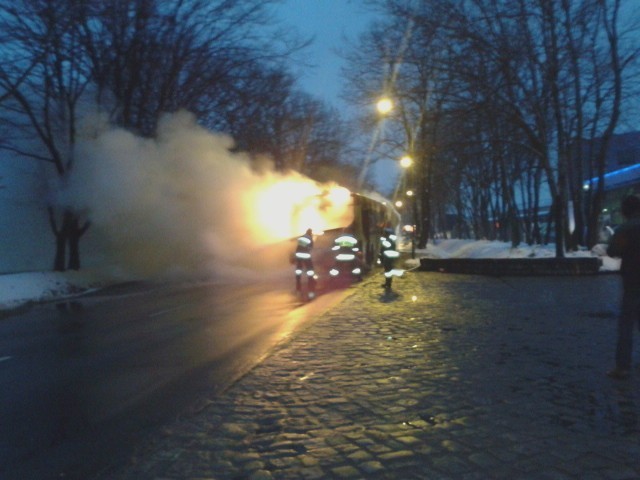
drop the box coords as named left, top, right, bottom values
left=96, top=273, right=640, bottom=480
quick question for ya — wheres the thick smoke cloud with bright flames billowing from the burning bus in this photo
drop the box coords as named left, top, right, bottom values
left=64, top=112, right=348, bottom=277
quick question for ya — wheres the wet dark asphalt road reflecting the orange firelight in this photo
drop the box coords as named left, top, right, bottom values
left=0, top=279, right=348, bottom=479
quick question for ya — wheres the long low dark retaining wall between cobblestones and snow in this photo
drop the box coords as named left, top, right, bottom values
left=420, top=257, right=601, bottom=276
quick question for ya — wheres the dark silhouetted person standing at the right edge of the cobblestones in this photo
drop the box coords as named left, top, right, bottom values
left=607, top=195, right=640, bottom=379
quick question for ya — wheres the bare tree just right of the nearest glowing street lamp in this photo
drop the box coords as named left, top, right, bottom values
left=345, top=2, right=444, bottom=247
